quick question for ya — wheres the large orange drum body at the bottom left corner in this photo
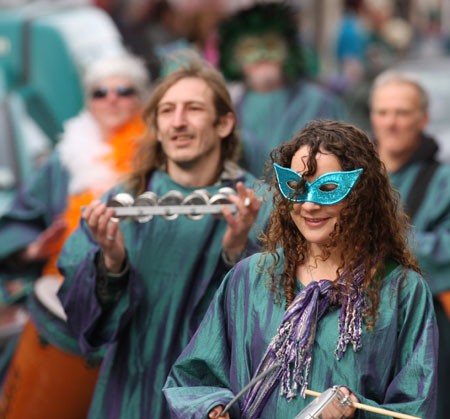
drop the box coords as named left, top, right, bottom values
left=0, top=320, right=100, bottom=419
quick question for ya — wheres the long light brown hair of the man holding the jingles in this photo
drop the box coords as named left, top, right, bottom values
left=128, top=53, right=240, bottom=194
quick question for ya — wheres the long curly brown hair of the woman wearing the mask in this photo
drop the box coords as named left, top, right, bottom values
left=260, top=121, right=420, bottom=328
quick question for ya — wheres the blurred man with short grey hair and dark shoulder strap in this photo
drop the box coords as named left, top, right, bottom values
left=370, top=71, right=450, bottom=419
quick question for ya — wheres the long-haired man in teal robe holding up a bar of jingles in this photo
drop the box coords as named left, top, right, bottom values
left=59, top=59, right=268, bottom=418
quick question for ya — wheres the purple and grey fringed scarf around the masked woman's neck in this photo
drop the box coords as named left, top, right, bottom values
left=241, top=264, right=367, bottom=419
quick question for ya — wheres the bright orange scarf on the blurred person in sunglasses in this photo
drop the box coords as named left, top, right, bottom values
left=42, top=117, right=145, bottom=280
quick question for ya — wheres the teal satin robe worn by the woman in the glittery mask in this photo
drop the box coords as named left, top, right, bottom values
left=164, top=254, right=437, bottom=419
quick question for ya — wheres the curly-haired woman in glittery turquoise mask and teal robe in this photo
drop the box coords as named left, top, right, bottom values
left=164, top=121, right=437, bottom=419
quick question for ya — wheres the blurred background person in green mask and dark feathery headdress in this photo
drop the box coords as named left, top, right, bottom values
left=219, top=2, right=345, bottom=177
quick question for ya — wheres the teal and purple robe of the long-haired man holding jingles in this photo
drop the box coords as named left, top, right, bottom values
left=58, top=170, right=271, bottom=419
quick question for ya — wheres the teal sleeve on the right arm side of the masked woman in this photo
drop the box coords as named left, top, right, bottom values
left=355, top=272, right=438, bottom=419
